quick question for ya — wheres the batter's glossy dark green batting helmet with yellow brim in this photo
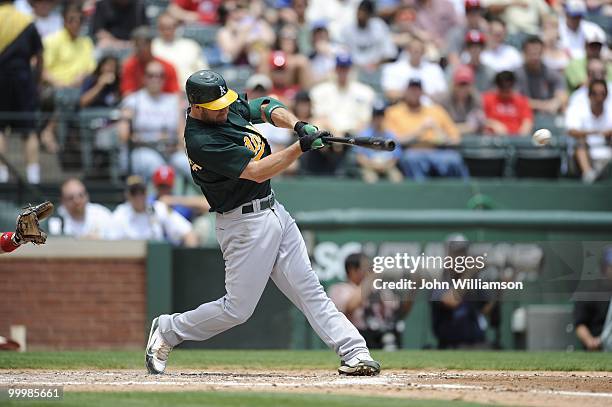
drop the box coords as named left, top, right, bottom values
left=185, top=69, right=238, bottom=110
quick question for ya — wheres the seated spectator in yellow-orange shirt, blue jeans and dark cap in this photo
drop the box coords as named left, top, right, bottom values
left=385, top=79, right=468, bottom=181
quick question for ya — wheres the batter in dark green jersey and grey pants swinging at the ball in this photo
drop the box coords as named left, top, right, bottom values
left=145, top=70, right=380, bottom=376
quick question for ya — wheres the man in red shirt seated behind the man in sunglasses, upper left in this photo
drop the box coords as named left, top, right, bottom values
left=121, top=27, right=179, bottom=96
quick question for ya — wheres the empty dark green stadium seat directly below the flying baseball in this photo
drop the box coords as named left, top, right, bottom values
left=514, top=148, right=561, bottom=178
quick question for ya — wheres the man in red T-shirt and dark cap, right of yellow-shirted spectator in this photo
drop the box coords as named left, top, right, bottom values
left=482, top=71, right=533, bottom=136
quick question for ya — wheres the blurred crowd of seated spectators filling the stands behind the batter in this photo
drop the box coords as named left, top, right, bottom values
left=0, top=0, right=612, bottom=183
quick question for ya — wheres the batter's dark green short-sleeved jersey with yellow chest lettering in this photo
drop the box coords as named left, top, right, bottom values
left=185, top=97, right=271, bottom=212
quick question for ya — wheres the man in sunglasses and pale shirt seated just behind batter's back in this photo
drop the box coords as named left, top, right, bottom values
left=119, top=61, right=191, bottom=179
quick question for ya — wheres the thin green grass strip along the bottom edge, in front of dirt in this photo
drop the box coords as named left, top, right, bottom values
left=0, top=392, right=483, bottom=407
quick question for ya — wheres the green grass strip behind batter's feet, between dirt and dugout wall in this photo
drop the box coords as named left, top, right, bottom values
left=0, top=349, right=612, bottom=371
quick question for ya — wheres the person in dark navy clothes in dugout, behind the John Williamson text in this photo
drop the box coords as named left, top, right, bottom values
left=430, top=236, right=494, bottom=349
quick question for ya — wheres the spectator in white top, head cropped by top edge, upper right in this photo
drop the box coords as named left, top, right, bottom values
left=483, top=0, right=552, bottom=35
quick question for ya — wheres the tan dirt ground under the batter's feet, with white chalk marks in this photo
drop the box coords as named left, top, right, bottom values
left=0, top=369, right=612, bottom=407
